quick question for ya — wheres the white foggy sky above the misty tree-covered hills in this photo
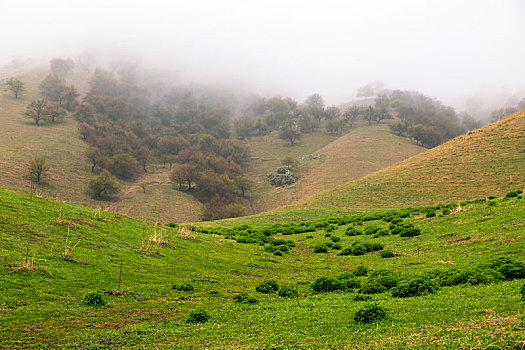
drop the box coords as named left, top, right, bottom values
left=0, top=0, right=525, bottom=104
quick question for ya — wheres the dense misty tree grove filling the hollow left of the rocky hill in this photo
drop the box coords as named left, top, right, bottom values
left=75, top=69, right=251, bottom=219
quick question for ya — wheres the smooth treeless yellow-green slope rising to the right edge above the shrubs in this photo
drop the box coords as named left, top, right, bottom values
left=291, top=111, right=525, bottom=208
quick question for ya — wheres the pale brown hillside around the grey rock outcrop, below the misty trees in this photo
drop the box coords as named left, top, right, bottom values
left=247, top=124, right=425, bottom=212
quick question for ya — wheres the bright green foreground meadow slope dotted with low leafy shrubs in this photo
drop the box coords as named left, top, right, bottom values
left=0, top=188, right=525, bottom=349
